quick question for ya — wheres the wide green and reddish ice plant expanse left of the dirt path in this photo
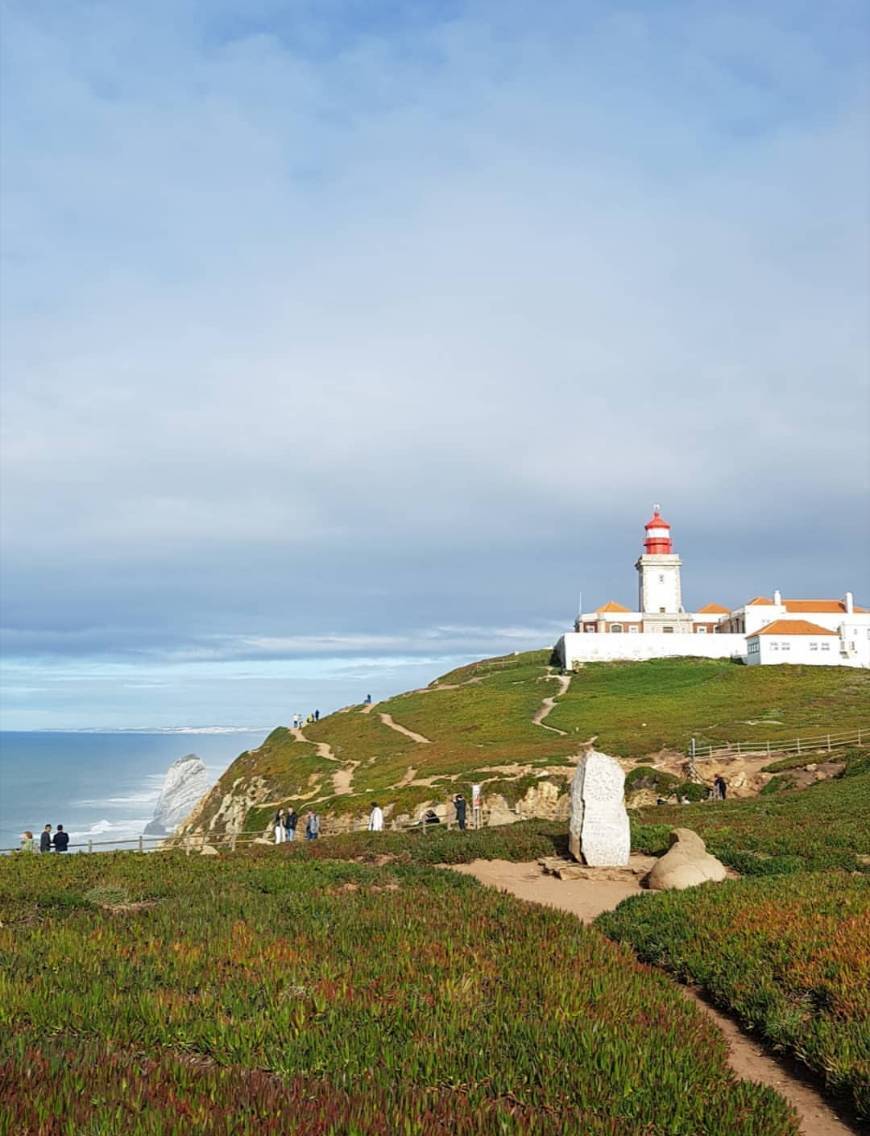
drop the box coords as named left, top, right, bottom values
left=0, top=849, right=797, bottom=1136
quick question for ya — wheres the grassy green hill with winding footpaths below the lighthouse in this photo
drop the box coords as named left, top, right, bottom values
left=182, top=651, right=870, bottom=833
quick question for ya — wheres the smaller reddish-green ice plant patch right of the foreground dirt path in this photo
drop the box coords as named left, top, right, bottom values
left=597, top=871, right=870, bottom=1119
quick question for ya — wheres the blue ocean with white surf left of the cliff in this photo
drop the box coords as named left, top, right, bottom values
left=0, top=728, right=268, bottom=849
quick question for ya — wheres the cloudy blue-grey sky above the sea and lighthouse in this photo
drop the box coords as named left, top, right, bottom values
left=0, top=0, right=870, bottom=729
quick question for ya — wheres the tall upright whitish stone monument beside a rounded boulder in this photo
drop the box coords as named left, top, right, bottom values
left=568, top=750, right=631, bottom=868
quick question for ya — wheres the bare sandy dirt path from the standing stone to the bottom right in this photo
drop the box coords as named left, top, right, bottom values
left=453, top=860, right=859, bottom=1136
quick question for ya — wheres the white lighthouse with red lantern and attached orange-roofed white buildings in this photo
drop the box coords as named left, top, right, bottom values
left=557, top=506, right=870, bottom=669
